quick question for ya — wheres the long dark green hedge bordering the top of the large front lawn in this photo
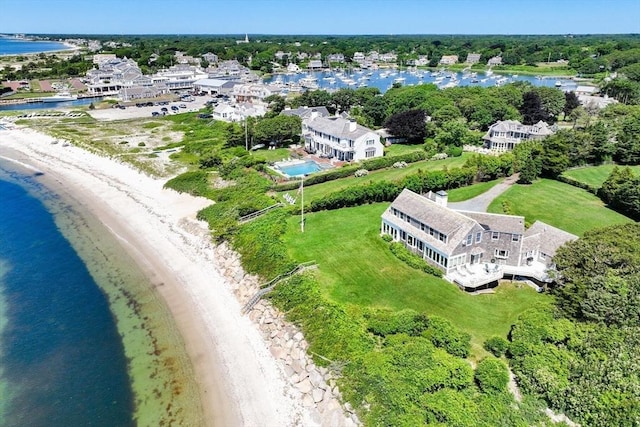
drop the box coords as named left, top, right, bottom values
left=309, top=168, right=475, bottom=212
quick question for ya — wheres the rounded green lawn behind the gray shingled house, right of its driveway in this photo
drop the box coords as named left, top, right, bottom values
left=488, top=179, right=631, bottom=236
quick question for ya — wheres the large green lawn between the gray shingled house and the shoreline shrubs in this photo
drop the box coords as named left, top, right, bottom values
left=285, top=203, right=551, bottom=357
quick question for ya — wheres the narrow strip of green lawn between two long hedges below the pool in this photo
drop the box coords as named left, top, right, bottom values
left=278, top=153, right=472, bottom=204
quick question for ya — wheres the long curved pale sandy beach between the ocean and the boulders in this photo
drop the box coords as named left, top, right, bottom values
left=0, top=128, right=316, bottom=426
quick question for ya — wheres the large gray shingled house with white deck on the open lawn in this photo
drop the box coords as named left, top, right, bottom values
left=381, top=189, right=578, bottom=291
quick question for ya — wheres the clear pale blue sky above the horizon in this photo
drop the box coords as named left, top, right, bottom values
left=0, top=0, right=640, bottom=34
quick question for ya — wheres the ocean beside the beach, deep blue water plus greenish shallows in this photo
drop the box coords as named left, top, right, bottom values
left=0, top=159, right=202, bottom=426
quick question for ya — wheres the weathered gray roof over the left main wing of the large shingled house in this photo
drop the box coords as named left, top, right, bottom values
left=382, top=188, right=477, bottom=254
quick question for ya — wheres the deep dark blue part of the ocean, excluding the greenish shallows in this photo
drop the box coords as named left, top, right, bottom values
left=0, top=169, right=134, bottom=426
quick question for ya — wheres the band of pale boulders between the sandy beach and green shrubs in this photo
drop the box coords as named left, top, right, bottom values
left=214, top=243, right=362, bottom=427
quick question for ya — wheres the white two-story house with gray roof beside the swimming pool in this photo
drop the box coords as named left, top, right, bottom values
left=302, top=112, right=384, bottom=162
